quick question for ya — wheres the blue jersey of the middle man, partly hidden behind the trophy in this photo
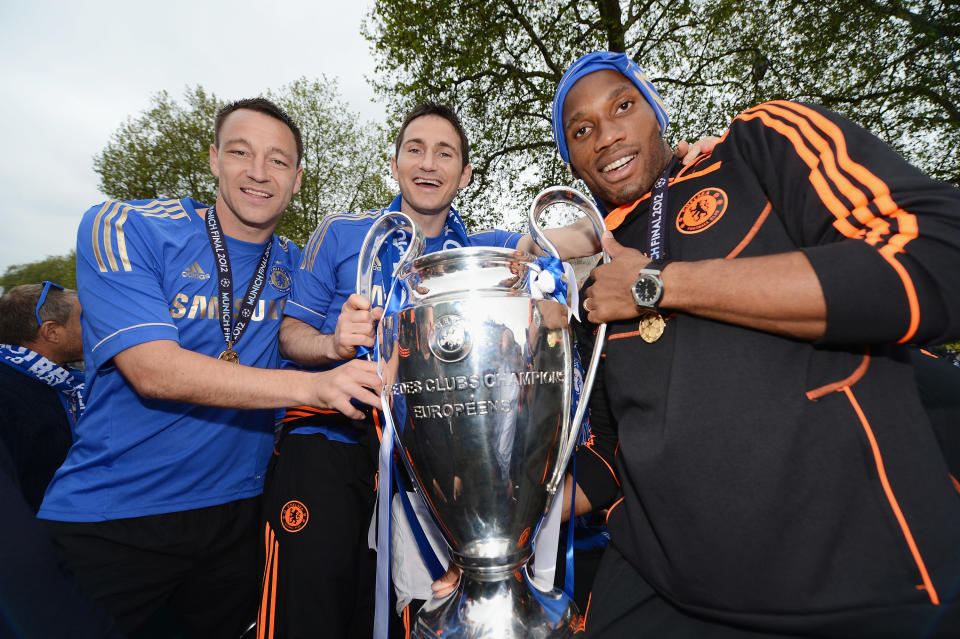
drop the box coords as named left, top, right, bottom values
left=284, top=195, right=523, bottom=441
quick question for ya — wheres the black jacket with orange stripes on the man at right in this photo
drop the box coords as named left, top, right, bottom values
left=592, top=102, right=960, bottom=637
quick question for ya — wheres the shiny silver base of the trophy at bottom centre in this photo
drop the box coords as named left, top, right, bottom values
left=411, top=567, right=579, bottom=639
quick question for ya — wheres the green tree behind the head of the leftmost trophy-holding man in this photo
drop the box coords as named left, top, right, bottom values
left=93, top=78, right=390, bottom=245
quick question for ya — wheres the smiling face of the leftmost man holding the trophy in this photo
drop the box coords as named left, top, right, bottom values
left=210, top=109, right=303, bottom=243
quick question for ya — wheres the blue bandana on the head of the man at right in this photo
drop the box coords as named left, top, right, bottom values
left=553, top=51, right=670, bottom=163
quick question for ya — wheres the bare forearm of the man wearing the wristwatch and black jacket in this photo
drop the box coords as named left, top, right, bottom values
left=660, top=251, right=827, bottom=340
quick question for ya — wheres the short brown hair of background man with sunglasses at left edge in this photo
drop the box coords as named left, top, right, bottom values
left=0, top=284, right=77, bottom=346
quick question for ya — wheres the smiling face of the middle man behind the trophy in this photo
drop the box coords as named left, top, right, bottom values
left=390, top=115, right=473, bottom=234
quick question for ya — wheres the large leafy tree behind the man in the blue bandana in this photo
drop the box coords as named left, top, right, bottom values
left=364, top=0, right=960, bottom=230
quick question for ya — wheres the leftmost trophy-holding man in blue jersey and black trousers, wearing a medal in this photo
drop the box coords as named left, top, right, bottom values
left=39, top=98, right=379, bottom=637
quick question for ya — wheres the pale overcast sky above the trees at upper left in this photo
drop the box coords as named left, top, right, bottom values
left=0, top=0, right=383, bottom=273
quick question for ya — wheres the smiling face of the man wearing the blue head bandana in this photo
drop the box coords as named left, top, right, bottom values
left=563, top=69, right=672, bottom=210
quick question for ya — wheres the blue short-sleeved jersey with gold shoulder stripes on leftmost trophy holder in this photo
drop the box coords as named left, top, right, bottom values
left=38, top=199, right=299, bottom=521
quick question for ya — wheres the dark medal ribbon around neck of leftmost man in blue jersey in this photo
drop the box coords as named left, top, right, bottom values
left=207, top=205, right=273, bottom=358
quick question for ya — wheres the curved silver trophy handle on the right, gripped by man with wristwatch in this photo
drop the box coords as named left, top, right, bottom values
left=527, top=186, right=610, bottom=495
